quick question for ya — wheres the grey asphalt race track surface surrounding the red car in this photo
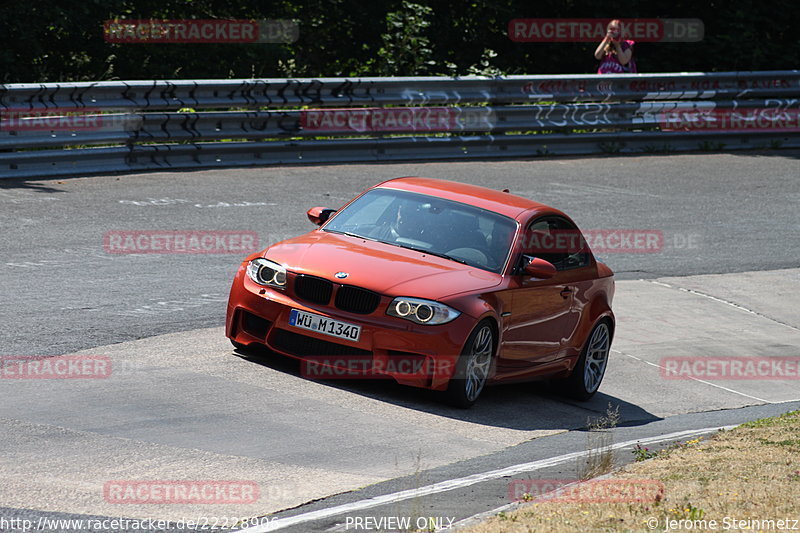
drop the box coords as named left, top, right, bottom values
left=0, top=151, right=800, bottom=532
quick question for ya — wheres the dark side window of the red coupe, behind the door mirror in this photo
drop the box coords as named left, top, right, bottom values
left=522, top=217, right=591, bottom=270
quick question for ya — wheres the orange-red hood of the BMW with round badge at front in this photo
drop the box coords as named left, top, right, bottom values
left=263, top=230, right=502, bottom=300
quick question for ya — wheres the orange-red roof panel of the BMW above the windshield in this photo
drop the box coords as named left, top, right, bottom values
left=374, top=177, right=562, bottom=219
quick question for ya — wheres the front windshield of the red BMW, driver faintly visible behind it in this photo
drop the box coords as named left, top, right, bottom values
left=323, top=188, right=516, bottom=273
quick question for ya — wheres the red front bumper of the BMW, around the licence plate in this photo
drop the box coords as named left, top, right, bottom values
left=225, top=268, right=475, bottom=390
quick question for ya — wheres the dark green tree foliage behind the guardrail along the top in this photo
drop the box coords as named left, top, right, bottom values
left=0, top=0, right=800, bottom=83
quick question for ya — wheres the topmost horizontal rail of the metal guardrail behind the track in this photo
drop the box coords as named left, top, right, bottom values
left=0, top=70, right=800, bottom=110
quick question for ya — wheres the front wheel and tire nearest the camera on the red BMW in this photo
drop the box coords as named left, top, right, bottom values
left=445, top=320, right=495, bottom=409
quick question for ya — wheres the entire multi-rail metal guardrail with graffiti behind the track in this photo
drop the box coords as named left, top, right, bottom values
left=0, top=70, right=800, bottom=177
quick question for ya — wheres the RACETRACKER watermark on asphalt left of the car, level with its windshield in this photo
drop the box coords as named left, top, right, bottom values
left=103, top=230, right=259, bottom=254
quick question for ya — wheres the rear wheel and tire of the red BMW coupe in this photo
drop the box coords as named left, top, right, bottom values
left=561, top=320, right=611, bottom=400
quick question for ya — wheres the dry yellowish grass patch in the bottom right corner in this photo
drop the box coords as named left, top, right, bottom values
left=465, top=411, right=800, bottom=533
